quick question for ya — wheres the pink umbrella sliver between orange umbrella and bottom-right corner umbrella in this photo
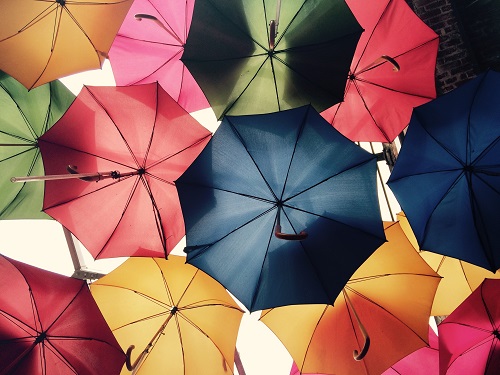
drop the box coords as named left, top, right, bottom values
left=382, top=326, right=442, bottom=375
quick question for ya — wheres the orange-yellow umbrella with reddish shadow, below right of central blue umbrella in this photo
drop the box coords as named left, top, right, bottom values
left=260, top=222, right=440, bottom=375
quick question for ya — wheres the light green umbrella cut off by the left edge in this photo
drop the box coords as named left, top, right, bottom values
left=0, top=72, right=75, bottom=219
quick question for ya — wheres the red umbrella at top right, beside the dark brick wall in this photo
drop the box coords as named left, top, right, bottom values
left=322, top=0, right=439, bottom=142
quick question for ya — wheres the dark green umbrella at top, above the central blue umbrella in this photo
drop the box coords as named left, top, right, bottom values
left=181, top=0, right=363, bottom=119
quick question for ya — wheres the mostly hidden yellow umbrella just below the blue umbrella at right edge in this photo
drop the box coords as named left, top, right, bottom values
left=396, top=212, right=500, bottom=316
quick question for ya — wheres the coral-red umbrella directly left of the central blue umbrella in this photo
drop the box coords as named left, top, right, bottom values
left=33, top=83, right=211, bottom=259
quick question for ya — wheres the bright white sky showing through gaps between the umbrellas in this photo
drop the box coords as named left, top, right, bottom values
left=0, top=60, right=399, bottom=375
